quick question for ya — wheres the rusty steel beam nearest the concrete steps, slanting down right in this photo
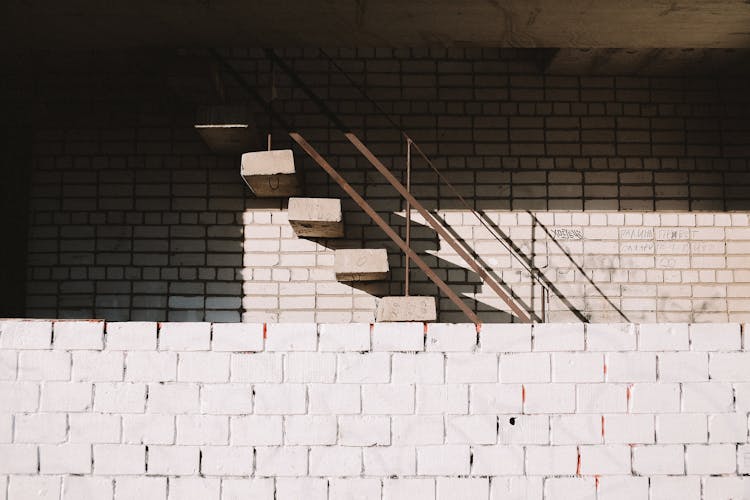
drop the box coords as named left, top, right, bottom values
left=289, top=132, right=481, bottom=324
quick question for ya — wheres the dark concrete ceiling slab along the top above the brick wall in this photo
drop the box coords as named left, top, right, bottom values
left=0, top=0, right=750, bottom=51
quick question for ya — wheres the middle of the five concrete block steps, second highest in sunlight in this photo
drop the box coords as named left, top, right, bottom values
left=288, top=198, right=344, bottom=238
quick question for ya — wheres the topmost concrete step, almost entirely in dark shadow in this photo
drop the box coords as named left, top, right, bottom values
left=195, top=105, right=259, bottom=154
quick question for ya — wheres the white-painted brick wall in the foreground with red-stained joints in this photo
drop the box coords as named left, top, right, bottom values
left=0, top=321, right=750, bottom=500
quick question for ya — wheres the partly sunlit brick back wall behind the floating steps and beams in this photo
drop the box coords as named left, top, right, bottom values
left=20, top=49, right=750, bottom=322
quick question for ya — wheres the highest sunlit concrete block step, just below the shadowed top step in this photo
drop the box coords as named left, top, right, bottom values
left=242, top=149, right=302, bottom=198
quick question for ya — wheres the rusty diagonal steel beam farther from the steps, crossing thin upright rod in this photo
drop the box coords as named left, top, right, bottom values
left=344, top=132, right=531, bottom=323
